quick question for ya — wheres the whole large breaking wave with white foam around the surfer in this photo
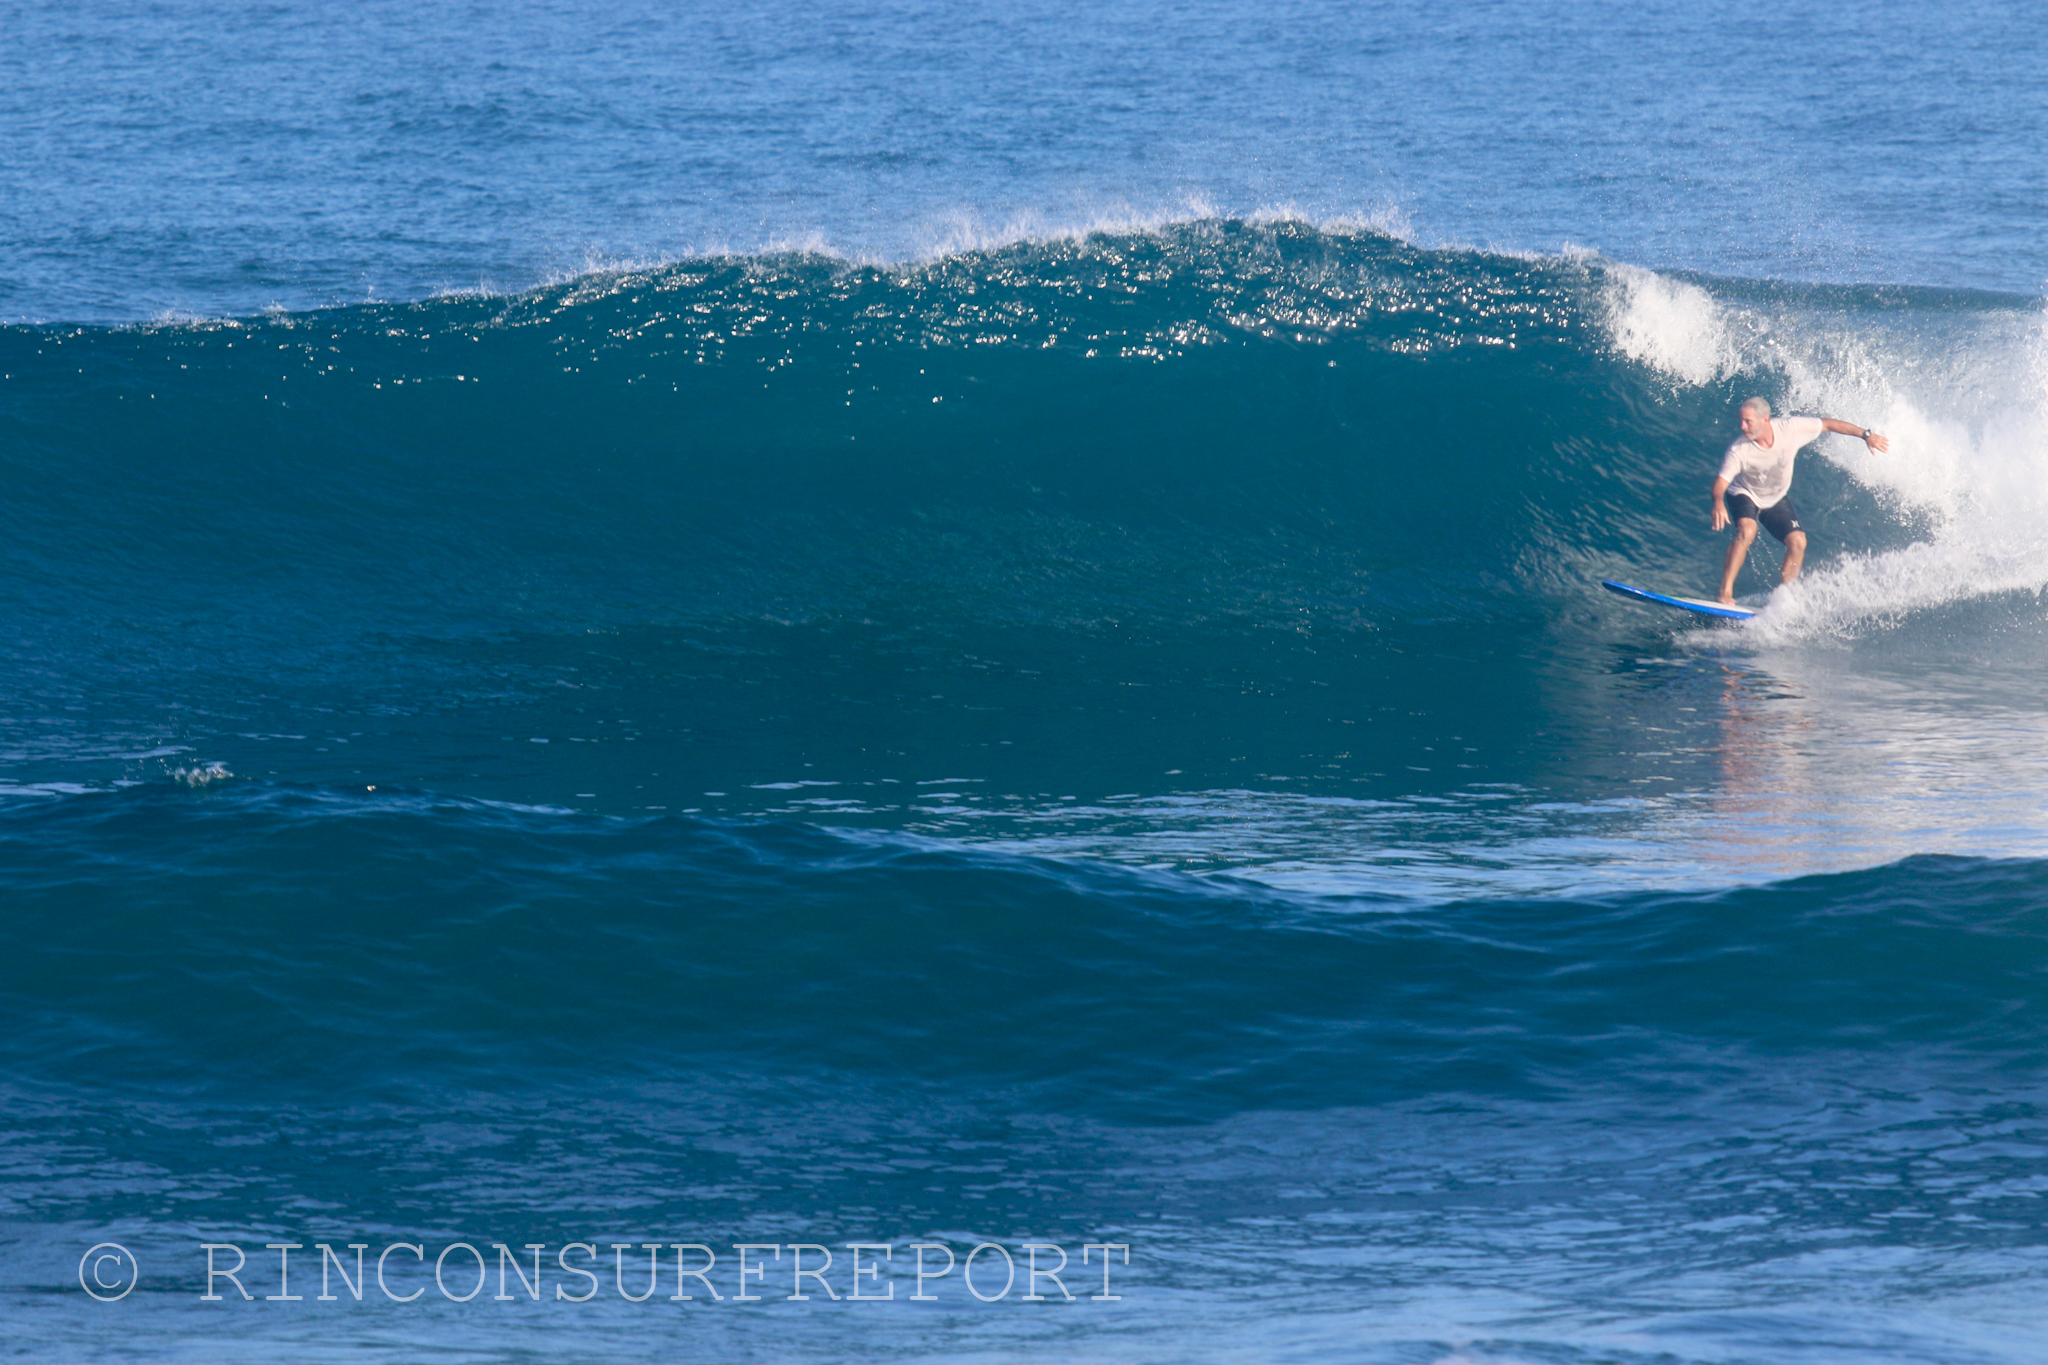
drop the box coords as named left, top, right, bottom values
left=0, top=221, right=2048, bottom=870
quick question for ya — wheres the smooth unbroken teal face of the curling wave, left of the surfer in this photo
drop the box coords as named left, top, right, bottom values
left=8, top=223, right=1683, bottom=628
